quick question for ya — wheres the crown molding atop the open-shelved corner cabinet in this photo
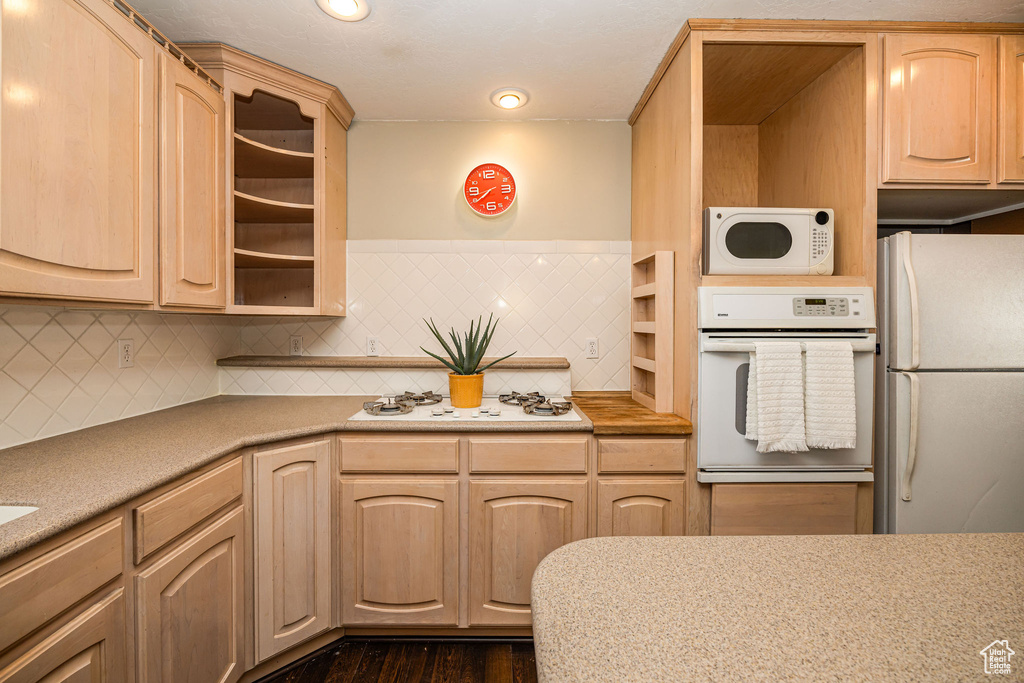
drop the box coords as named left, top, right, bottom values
left=178, top=43, right=355, bottom=130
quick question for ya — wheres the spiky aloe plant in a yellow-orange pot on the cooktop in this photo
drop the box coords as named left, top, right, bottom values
left=420, top=313, right=515, bottom=408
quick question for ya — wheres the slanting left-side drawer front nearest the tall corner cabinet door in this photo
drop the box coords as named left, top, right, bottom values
left=132, top=458, right=242, bottom=564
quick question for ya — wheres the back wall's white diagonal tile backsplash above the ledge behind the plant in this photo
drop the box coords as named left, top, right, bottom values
left=235, top=240, right=630, bottom=391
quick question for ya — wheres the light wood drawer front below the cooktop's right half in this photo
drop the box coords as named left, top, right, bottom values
left=469, top=436, right=587, bottom=473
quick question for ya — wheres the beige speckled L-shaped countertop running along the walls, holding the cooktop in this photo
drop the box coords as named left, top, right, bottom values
left=0, top=396, right=594, bottom=560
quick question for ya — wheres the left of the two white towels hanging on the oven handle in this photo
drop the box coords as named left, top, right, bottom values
left=746, top=342, right=807, bottom=453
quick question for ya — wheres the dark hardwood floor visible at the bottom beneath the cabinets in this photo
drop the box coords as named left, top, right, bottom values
left=260, top=639, right=537, bottom=683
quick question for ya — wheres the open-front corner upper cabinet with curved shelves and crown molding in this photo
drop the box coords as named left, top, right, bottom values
left=181, top=43, right=352, bottom=315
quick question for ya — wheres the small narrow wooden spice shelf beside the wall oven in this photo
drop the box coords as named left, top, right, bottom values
left=630, top=251, right=676, bottom=413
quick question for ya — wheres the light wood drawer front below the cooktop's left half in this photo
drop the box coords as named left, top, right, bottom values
left=341, top=436, right=459, bottom=472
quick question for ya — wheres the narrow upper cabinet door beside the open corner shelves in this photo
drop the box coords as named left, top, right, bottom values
left=160, top=54, right=226, bottom=308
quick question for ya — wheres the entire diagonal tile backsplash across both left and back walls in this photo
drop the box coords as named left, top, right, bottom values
left=0, top=240, right=630, bottom=449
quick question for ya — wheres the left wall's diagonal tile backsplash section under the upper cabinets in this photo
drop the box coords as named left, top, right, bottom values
left=0, top=306, right=242, bottom=447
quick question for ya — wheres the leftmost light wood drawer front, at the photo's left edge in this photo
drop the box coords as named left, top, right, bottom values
left=0, top=519, right=124, bottom=650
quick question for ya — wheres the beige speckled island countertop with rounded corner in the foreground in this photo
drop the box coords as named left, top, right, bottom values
left=532, top=533, right=1024, bottom=683
